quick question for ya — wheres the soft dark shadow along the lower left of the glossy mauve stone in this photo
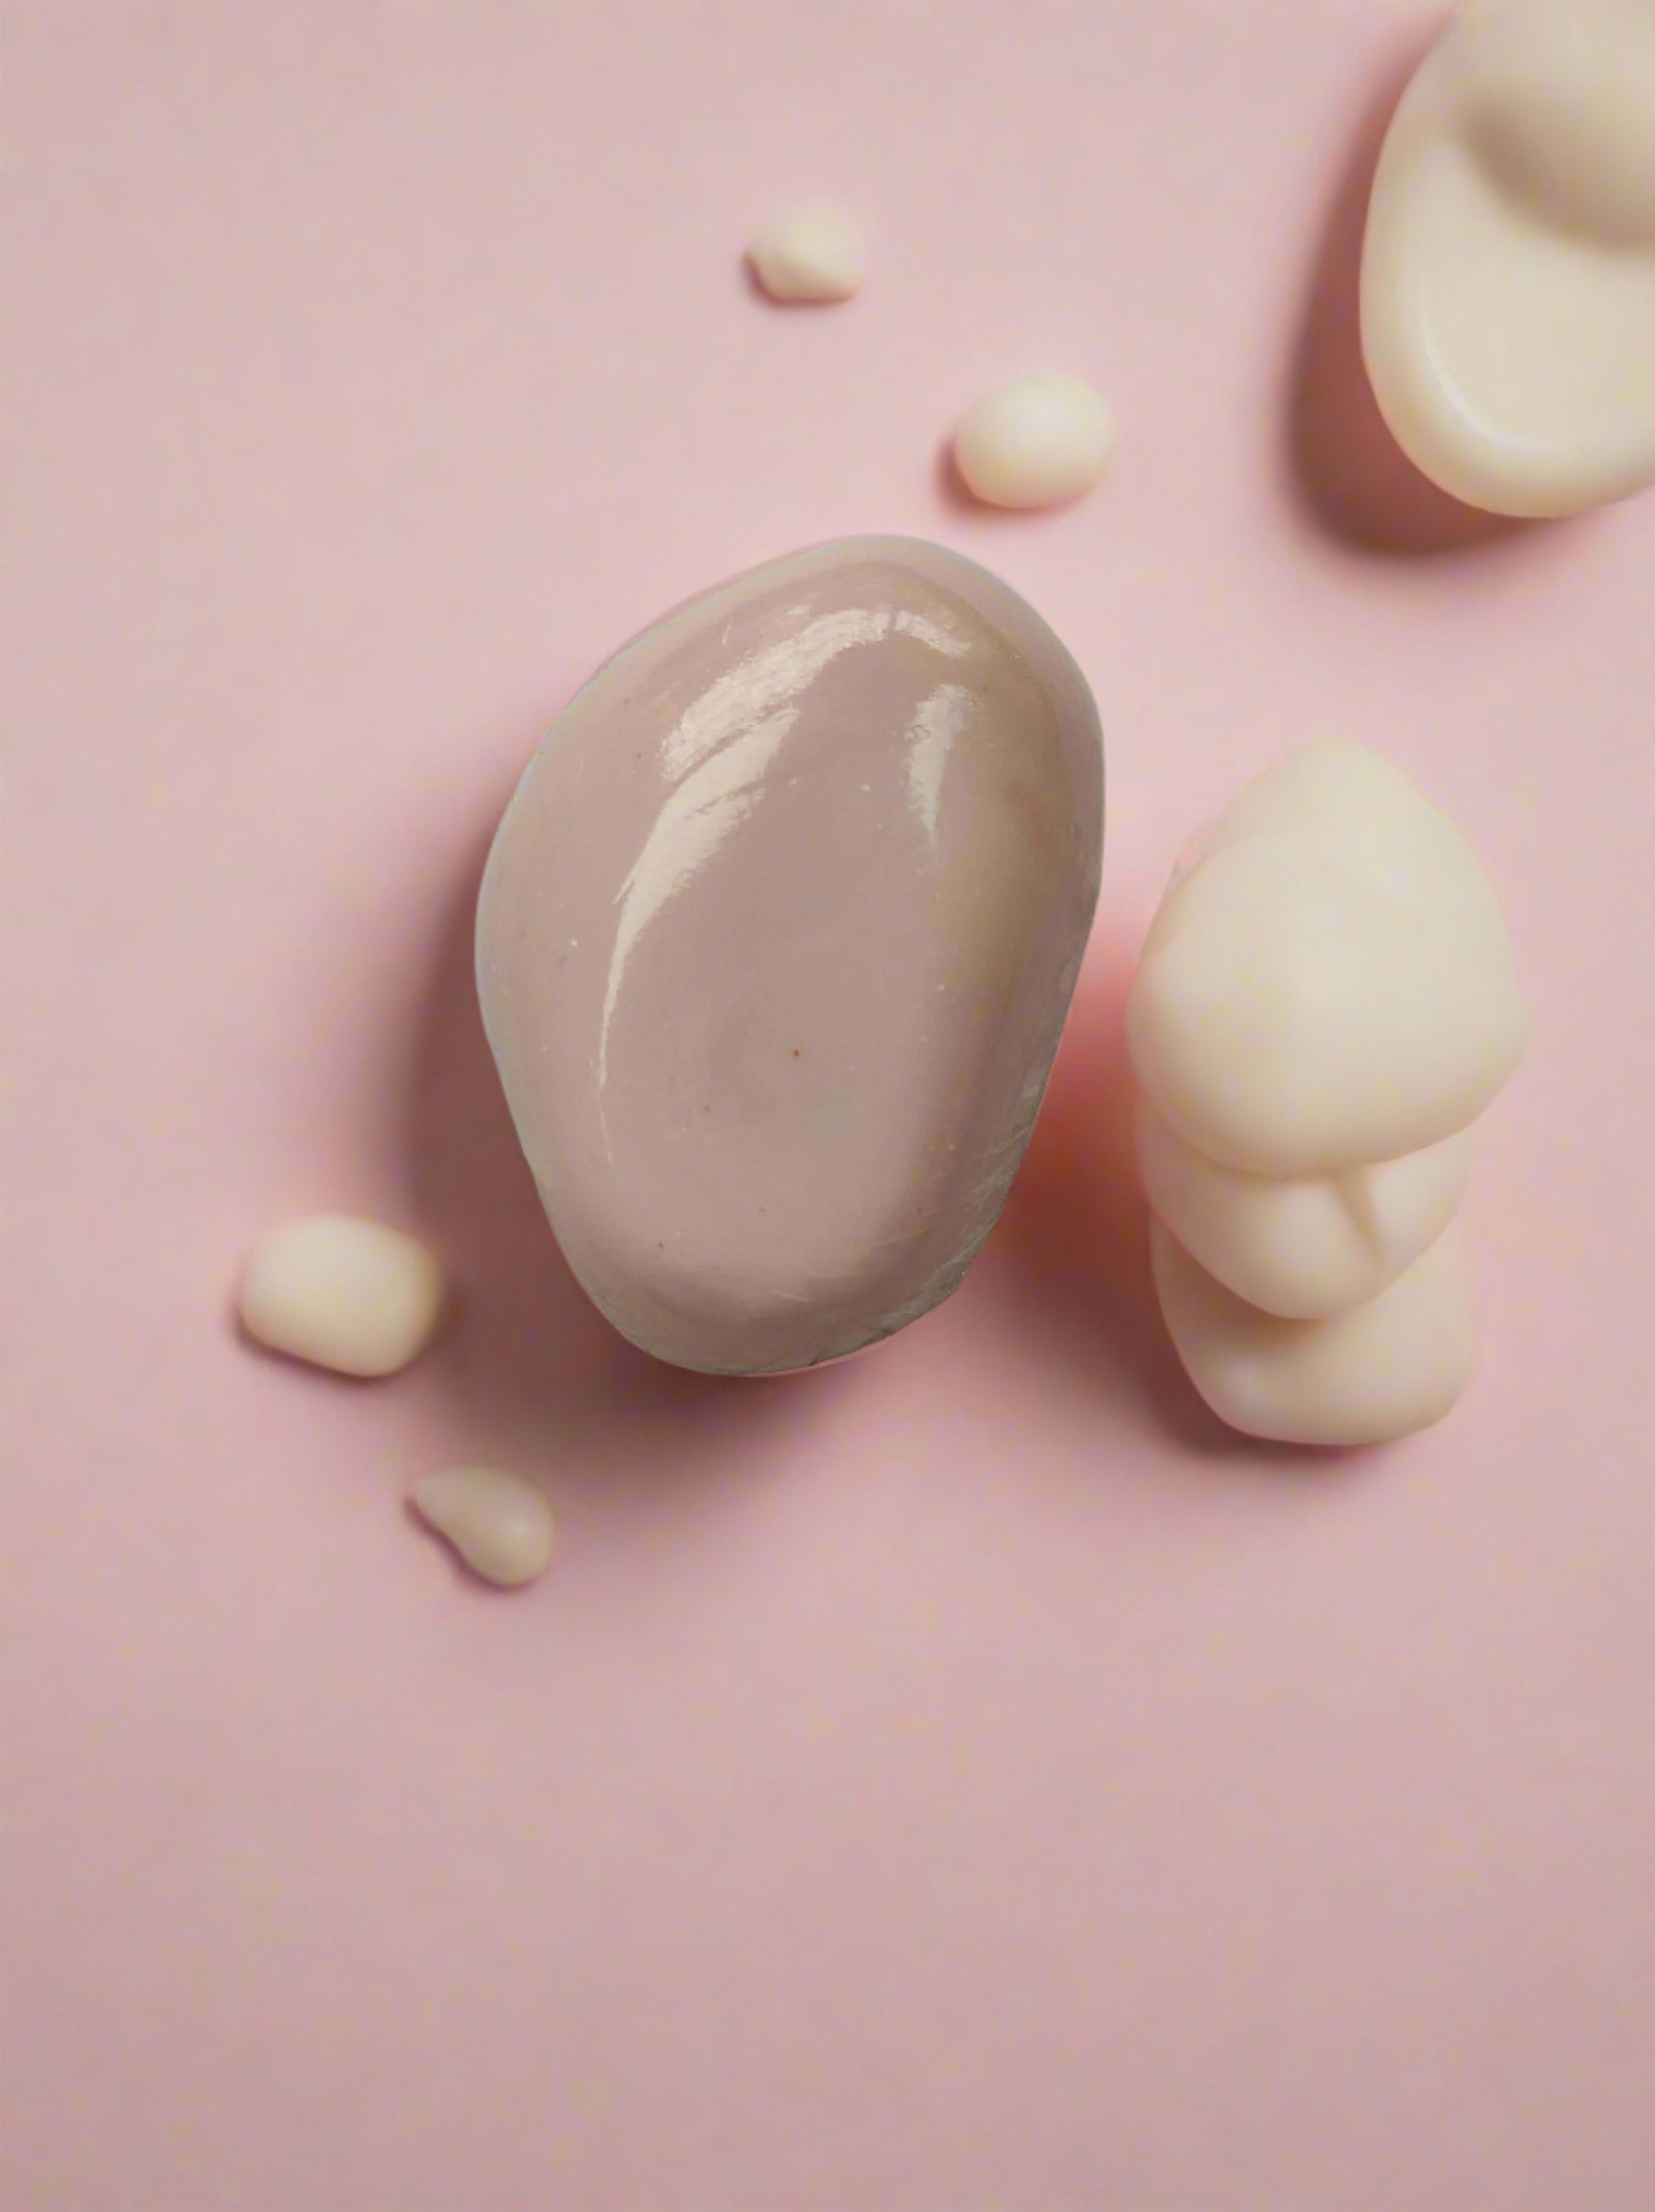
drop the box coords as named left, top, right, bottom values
left=407, top=796, right=854, bottom=1487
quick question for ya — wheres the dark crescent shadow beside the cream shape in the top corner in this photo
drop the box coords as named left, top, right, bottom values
left=1286, top=37, right=1533, bottom=557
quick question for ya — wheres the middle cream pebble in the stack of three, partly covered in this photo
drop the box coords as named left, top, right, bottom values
left=1137, top=1100, right=1474, bottom=1321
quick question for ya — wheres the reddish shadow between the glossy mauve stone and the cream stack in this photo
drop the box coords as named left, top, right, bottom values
left=985, top=923, right=1261, bottom=1458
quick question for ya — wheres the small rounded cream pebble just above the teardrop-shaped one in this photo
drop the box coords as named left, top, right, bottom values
left=239, top=1214, right=442, bottom=1376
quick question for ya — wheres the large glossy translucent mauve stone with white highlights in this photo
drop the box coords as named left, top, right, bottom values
left=478, top=537, right=1102, bottom=1373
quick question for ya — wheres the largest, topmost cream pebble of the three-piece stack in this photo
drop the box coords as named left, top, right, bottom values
left=1126, top=739, right=1527, bottom=1179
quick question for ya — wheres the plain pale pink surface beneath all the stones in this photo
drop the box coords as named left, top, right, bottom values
left=3, top=0, right=1655, bottom=2212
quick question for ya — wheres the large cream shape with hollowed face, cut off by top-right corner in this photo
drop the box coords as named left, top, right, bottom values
left=1361, top=0, right=1655, bottom=515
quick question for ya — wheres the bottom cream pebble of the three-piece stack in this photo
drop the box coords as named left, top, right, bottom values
left=1151, top=1221, right=1476, bottom=1444
